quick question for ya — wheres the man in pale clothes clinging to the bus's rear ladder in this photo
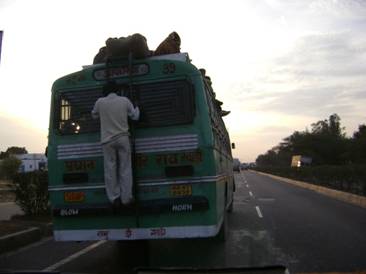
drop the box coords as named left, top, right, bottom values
left=92, top=82, right=140, bottom=207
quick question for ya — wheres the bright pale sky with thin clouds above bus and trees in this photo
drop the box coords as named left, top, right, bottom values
left=0, top=0, right=366, bottom=162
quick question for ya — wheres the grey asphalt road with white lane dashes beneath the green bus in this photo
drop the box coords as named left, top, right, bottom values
left=0, top=172, right=366, bottom=273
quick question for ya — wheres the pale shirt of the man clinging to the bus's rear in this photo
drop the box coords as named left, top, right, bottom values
left=92, top=93, right=140, bottom=144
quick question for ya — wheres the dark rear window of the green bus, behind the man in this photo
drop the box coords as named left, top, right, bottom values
left=55, top=81, right=195, bottom=134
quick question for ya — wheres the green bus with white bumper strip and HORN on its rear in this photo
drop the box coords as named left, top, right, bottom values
left=47, top=53, right=235, bottom=241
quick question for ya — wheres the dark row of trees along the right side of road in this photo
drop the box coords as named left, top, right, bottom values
left=256, top=113, right=366, bottom=167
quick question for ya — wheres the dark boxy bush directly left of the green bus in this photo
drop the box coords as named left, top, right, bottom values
left=14, top=171, right=50, bottom=216
